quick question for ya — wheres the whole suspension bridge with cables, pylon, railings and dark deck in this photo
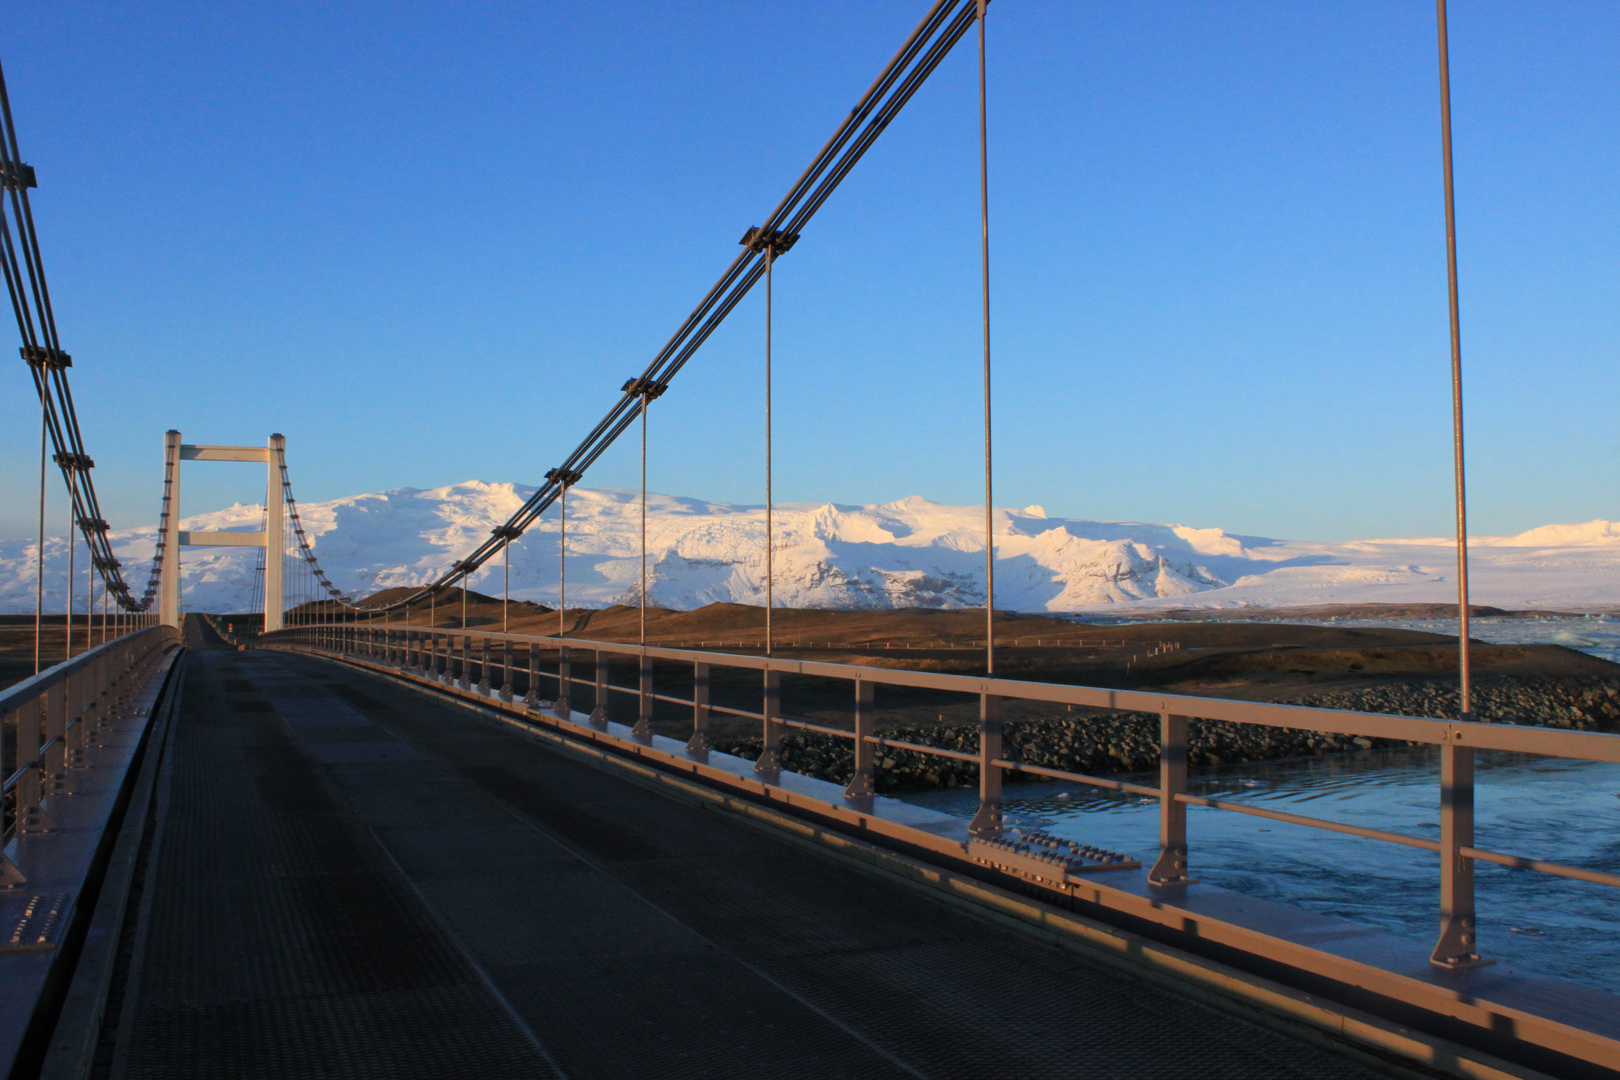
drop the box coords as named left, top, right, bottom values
left=0, top=0, right=1620, bottom=1077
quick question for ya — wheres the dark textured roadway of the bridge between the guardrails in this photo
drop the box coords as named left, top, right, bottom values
left=100, top=649, right=1371, bottom=1080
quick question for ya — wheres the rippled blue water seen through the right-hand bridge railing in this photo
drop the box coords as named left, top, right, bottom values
left=909, top=750, right=1620, bottom=989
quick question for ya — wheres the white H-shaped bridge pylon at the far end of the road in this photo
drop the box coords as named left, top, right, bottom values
left=157, top=431, right=287, bottom=631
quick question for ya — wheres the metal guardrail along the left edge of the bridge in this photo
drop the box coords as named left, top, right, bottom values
left=0, top=627, right=180, bottom=889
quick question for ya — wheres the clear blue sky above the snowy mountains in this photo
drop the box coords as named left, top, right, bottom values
left=0, top=0, right=1620, bottom=539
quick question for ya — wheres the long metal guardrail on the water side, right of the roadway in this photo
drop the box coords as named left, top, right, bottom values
left=275, top=623, right=1620, bottom=968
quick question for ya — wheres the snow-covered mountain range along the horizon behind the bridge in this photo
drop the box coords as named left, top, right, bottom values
left=0, top=481, right=1620, bottom=612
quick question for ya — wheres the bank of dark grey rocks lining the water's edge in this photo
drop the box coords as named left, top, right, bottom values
left=714, top=677, right=1620, bottom=792
